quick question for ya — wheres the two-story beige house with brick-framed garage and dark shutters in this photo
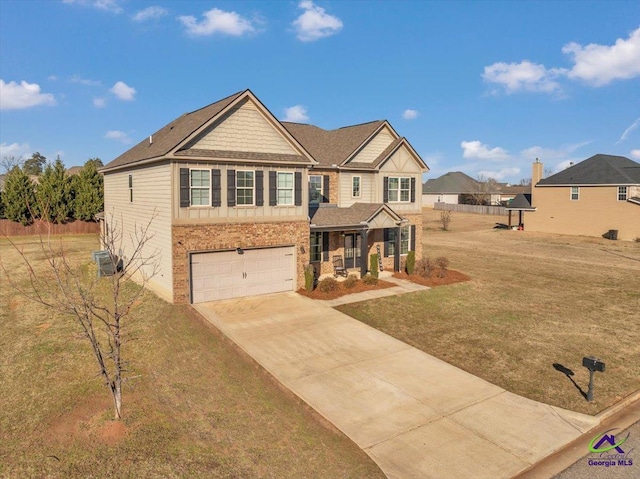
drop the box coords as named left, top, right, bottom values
left=101, top=90, right=428, bottom=303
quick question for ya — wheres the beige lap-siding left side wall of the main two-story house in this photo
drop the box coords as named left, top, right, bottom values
left=104, top=163, right=173, bottom=301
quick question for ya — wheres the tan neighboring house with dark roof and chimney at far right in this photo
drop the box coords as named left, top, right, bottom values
left=525, top=154, right=640, bottom=240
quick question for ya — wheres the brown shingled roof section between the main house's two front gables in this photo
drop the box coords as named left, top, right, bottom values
left=282, top=120, right=386, bottom=167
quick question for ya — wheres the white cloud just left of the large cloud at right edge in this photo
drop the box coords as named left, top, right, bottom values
left=482, top=60, right=562, bottom=94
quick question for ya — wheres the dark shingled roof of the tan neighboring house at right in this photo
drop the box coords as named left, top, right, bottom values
left=536, top=154, right=640, bottom=186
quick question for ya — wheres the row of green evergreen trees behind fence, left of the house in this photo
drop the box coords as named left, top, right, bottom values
left=0, top=153, right=104, bottom=225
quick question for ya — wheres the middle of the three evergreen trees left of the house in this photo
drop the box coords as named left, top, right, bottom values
left=36, top=158, right=72, bottom=223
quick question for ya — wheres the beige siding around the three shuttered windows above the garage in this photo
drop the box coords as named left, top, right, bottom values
left=172, top=162, right=309, bottom=223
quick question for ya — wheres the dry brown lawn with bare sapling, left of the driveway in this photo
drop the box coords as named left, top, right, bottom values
left=0, top=236, right=383, bottom=478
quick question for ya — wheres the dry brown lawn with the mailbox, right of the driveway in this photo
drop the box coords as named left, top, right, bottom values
left=339, top=210, right=640, bottom=414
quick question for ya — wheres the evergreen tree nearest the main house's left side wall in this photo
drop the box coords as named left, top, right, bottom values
left=73, top=158, right=104, bottom=221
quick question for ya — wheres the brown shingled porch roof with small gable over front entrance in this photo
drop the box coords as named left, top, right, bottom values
left=309, top=203, right=402, bottom=230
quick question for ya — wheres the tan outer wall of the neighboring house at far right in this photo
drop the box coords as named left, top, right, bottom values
left=524, top=186, right=640, bottom=240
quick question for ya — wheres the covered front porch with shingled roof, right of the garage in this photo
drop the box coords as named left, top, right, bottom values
left=310, top=203, right=415, bottom=278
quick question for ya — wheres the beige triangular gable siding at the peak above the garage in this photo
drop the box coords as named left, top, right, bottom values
left=190, top=100, right=300, bottom=154
